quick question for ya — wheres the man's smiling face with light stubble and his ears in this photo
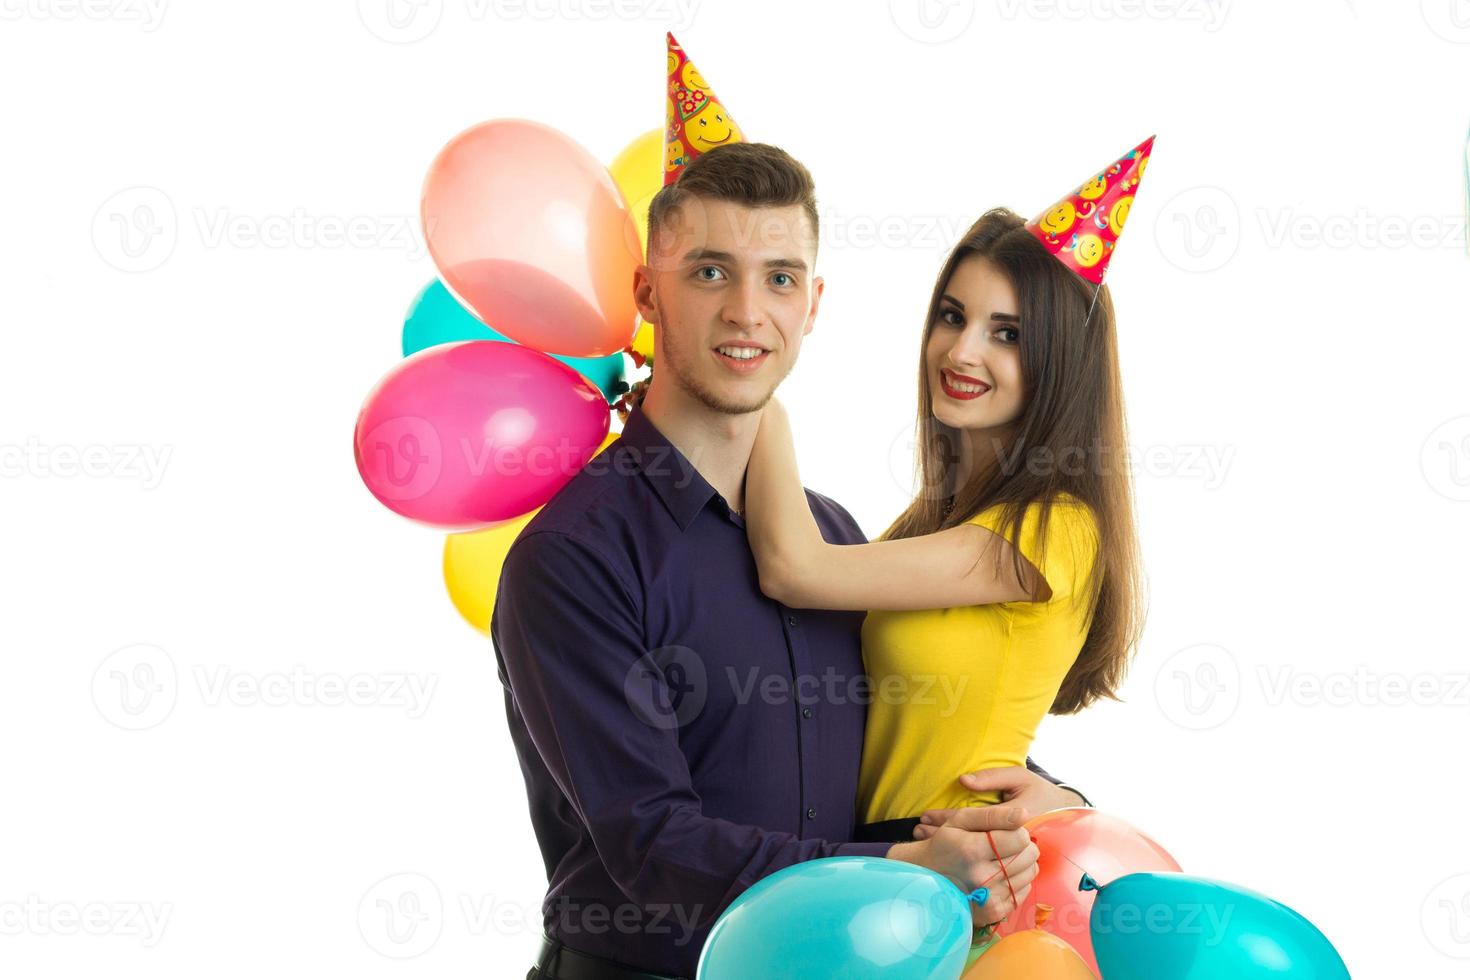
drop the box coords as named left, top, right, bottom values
left=634, top=198, right=822, bottom=414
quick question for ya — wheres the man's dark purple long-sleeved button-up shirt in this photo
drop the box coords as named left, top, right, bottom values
left=491, top=410, right=1058, bottom=977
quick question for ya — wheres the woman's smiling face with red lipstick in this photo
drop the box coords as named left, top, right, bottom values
left=925, top=256, right=1028, bottom=430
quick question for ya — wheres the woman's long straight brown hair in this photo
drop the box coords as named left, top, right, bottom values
left=882, top=207, right=1144, bottom=714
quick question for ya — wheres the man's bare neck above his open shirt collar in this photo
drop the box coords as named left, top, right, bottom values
left=641, top=378, right=760, bottom=511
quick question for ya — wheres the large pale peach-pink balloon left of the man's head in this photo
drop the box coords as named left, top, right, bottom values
left=420, top=119, right=642, bottom=357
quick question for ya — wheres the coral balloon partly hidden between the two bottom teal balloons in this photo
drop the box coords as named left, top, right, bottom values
left=980, top=807, right=1179, bottom=973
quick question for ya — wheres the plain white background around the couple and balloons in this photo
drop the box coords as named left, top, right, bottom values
left=0, top=0, right=1470, bottom=979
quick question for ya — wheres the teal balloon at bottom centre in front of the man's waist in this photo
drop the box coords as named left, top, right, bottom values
left=698, top=857, right=972, bottom=980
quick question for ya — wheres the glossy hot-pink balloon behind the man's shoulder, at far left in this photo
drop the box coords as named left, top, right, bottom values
left=353, top=341, right=612, bottom=530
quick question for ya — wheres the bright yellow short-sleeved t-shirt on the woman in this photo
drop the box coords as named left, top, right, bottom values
left=857, top=494, right=1098, bottom=823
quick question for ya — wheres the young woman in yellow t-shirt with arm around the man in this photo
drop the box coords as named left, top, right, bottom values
left=745, top=209, right=1142, bottom=863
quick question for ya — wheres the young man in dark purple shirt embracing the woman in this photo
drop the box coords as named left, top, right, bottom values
left=491, top=143, right=1082, bottom=980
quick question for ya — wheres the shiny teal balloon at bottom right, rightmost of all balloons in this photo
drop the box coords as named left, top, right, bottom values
left=1091, top=871, right=1348, bottom=980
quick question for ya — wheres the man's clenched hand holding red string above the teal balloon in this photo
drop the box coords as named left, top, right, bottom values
left=888, top=807, right=1039, bottom=926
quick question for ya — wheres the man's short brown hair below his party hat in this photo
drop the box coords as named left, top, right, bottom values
left=648, top=143, right=817, bottom=258
